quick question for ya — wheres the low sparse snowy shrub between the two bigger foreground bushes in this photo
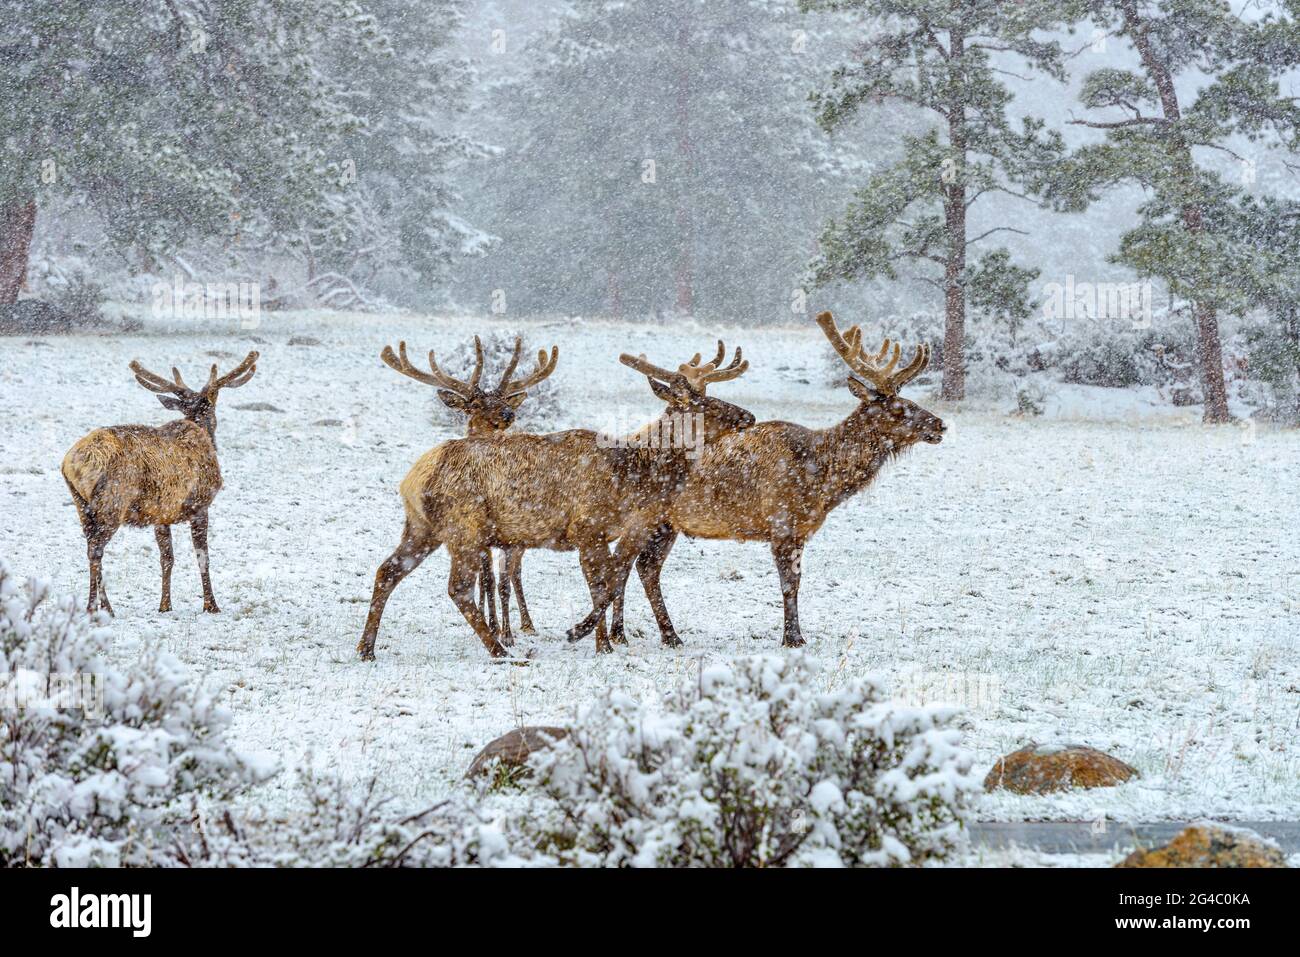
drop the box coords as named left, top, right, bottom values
left=179, top=767, right=520, bottom=867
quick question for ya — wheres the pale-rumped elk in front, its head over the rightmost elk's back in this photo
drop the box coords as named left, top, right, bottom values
left=358, top=350, right=754, bottom=659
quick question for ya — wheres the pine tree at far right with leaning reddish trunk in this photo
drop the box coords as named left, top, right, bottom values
left=1045, top=0, right=1300, bottom=423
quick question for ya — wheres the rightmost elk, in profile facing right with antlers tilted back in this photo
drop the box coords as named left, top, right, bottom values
left=611, top=312, right=946, bottom=648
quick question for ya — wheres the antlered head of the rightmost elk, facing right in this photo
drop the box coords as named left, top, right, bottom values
left=816, top=312, right=948, bottom=449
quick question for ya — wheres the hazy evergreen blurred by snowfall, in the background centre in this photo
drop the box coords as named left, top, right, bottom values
left=457, top=0, right=863, bottom=321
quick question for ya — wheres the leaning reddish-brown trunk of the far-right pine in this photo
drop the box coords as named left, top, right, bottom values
left=1121, top=0, right=1232, bottom=423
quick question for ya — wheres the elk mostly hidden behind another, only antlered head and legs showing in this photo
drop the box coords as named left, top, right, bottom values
left=380, top=335, right=560, bottom=645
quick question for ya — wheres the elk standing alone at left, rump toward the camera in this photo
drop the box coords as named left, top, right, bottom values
left=62, top=352, right=257, bottom=615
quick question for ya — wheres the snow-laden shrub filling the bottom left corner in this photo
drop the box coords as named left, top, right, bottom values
left=0, top=559, right=265, bottom=866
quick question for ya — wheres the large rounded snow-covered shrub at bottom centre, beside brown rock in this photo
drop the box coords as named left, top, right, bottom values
left=519, top=654, right=978, bottom=867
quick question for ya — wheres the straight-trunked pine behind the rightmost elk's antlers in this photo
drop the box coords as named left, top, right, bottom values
left=801, top=0, right=1063, bottom=399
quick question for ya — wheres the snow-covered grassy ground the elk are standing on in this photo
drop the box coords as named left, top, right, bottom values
left=0, top=313, right=1300, bottom=862
